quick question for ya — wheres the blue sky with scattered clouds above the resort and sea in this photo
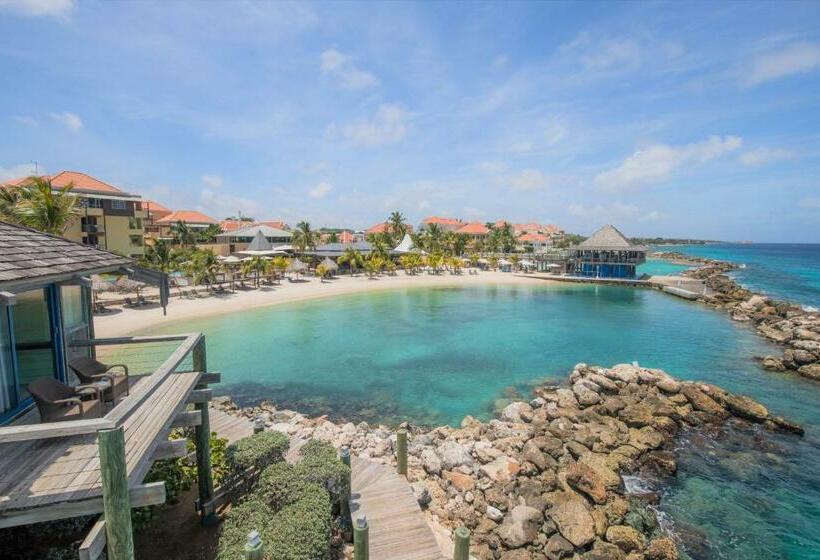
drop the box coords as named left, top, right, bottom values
left=0, top=0, right=820, bottom=242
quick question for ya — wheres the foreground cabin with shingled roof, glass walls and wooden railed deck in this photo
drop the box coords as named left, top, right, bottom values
left=0, top=222, right=219, bottom=558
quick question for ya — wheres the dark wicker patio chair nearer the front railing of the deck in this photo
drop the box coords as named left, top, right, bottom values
left=26, top=377, right=103, bottom=422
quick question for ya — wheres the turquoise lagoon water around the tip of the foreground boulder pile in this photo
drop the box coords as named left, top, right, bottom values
left=149, top=285, right=820, bottom=560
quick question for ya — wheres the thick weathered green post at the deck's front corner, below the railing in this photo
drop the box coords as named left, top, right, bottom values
left=97, top=426, right=134, bottom=560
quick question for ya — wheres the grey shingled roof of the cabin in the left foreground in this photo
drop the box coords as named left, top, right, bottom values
left=0, top=221, right=132, bottom=288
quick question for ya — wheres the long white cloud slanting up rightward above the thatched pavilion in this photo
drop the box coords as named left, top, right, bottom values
left=595, top=136, right=743, bottom=191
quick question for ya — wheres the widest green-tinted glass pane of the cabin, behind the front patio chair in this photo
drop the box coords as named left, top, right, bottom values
left=12, top=290, right=56, bottom=400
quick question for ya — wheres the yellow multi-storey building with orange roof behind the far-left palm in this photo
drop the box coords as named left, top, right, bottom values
left=4, top=171, right=148, bottom=258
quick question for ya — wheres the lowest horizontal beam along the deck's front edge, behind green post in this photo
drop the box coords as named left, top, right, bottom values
left=0, top=481, right=165, bottom=529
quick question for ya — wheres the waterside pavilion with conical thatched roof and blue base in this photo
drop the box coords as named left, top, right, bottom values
left=569, top=225, right=647, bottom=278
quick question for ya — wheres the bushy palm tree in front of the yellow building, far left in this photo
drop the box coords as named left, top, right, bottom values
left=0, top=177, right=82, bottom=235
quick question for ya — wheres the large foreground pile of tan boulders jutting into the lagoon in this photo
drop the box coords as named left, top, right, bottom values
left=218, top=364, right=802, bottom=560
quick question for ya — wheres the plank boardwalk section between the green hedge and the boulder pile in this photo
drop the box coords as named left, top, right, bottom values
left=350, top=457, right=444, bottom=560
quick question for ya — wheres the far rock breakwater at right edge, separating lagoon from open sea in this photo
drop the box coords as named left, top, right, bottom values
left=683, top=262, right=820, bottom=381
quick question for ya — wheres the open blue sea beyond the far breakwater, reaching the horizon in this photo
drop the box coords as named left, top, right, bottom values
left=661, top=243, right=820, bottom=308
